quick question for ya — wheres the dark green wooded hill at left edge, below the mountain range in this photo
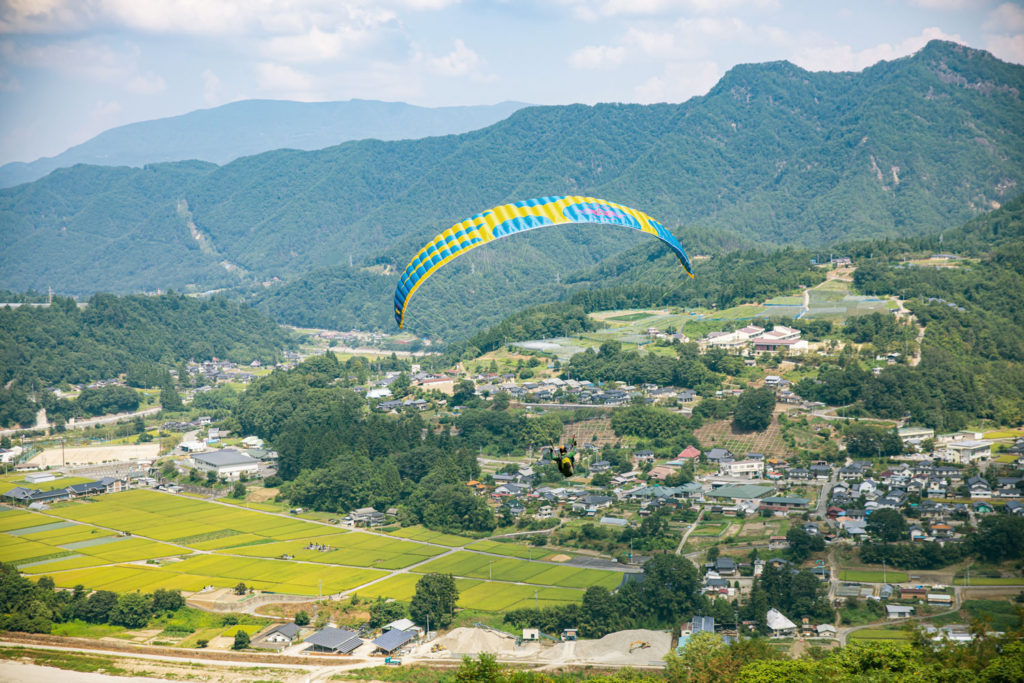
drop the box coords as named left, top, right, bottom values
left=0, top=294, right=290, bottom=426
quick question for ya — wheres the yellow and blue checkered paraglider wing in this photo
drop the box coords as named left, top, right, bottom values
left=394, top=197, right=693, bottom=328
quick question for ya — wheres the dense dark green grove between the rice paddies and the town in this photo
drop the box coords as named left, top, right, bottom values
left=233, top=353, right=496, bottom=531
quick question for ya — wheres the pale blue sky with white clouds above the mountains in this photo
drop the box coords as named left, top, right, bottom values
left=0, top=0, right=1024, bottom=163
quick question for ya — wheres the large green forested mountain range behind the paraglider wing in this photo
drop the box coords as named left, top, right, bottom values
left=0, top=41, right=1024, bottom=333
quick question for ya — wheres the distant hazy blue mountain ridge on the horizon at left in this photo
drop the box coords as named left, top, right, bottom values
left=0, top=99, right=526, bottom=187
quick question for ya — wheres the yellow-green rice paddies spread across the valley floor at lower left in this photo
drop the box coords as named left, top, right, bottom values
left=0, top=489, right=621, bottom=610
